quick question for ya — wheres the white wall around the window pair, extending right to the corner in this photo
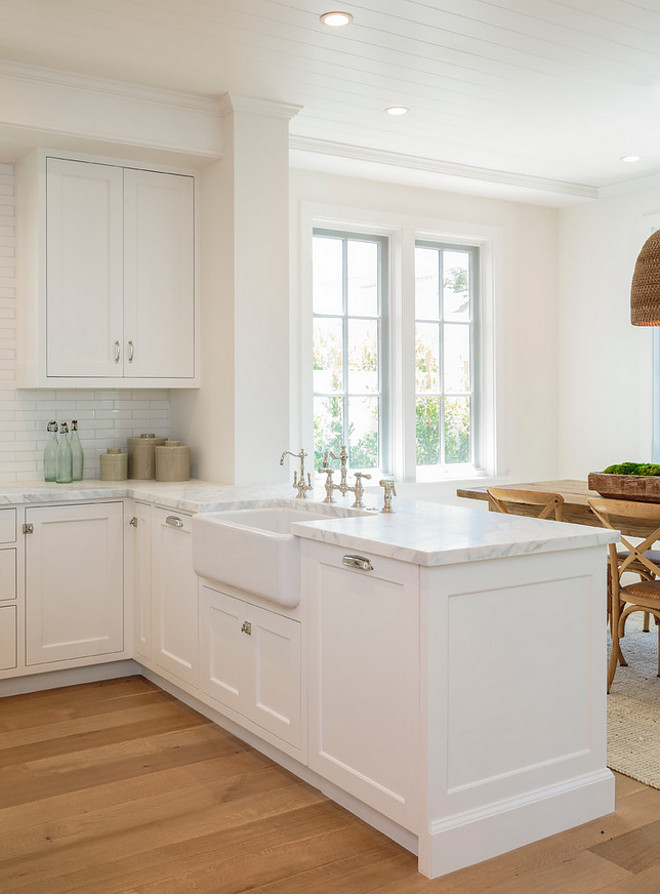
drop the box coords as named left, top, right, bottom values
left=290, top=170, right=559, bottom=500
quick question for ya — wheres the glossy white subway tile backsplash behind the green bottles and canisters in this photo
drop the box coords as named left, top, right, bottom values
left=0, top=164, right=169, bottom=482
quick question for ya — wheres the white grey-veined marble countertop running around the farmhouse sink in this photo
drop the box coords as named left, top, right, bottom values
left=0, top=480, right=617, bottom=565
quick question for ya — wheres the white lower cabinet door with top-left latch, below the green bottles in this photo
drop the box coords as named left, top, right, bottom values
left=25, top=503, right=124, bottom=665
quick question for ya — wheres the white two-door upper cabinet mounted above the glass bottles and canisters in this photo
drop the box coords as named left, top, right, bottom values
left=16, top=150, right=199, bottom=388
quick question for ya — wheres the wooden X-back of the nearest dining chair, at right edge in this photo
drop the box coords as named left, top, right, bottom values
left=589, top=497, right=660, bottom=578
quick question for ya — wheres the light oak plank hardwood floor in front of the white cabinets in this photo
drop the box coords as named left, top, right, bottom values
left=0, top=677, right=660, bottom=894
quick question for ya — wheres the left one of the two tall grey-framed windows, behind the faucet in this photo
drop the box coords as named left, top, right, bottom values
left=312, top=230, right=389, bottom=469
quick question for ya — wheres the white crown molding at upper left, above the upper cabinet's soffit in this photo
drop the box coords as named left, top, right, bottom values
left=0, top=60, right=221, bottom=116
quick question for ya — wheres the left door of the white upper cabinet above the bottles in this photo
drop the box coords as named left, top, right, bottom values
left=46, top=158, right=124, bottom=377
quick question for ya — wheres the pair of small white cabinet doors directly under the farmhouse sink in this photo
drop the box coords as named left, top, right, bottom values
left=200, top=584, right=302, bottom=748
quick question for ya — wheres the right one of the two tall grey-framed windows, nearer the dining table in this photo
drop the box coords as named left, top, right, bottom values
left=415, top=242, right=478, bottom=477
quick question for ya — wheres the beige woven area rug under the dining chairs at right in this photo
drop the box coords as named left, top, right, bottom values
left=607, top=612, right=660, bottom=789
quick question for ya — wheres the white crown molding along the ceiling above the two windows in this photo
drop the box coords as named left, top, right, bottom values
left=289, top=135, right=599, bottom=199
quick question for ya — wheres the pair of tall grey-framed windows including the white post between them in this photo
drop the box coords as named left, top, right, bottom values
left=301, top=216, right=488, bottom=481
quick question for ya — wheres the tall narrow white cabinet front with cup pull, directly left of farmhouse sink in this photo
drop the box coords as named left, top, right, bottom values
left=151, top=509, right=199, bottom=687
